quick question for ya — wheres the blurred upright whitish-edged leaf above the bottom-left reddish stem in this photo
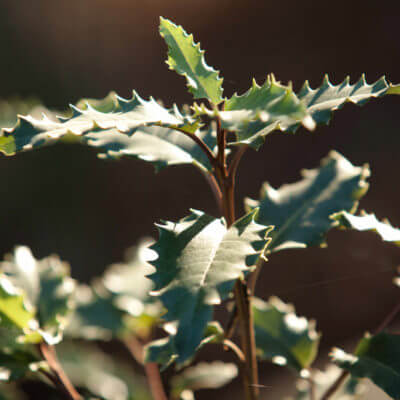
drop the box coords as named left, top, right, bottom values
left=0, top=246, right=75, bottom=344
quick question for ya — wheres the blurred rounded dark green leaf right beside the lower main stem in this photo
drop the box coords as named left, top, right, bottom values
left=252, top=297, right=320, bottom=372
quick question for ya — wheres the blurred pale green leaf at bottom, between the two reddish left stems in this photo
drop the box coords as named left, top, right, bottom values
left=57, top=343, right=151, bottom=400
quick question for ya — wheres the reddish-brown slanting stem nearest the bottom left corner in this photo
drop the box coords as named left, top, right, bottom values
left=38, top=342, right=82, bottom=400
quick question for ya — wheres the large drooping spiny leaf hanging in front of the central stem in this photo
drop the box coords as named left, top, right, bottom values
left=149, top=211, right=268, bottom=363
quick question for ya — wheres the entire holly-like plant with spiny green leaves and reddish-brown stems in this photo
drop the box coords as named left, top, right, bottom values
left=0, top=18, right=400, bottom=400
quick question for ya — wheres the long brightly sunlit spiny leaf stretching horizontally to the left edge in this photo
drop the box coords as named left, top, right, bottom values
left=0, top=92, right=199, bottom=155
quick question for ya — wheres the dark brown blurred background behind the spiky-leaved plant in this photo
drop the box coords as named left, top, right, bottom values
left=0, top=0, right=400, bottom=398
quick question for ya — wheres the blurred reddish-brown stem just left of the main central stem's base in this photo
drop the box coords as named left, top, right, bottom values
left=123, top=336, right=168, bottom=400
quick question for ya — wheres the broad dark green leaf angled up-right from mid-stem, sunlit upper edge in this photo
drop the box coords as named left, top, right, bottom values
left=245, top=151, right=369, bottom=252
